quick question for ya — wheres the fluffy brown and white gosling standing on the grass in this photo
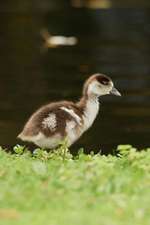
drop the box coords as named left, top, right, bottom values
left=18, top=74, right=121, bottom=149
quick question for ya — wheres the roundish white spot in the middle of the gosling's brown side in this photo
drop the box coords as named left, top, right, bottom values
left=42, top=113, right=57, bottom=132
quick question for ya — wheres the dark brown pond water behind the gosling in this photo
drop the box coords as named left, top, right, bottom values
left=0, top=8, right=150, bottom=152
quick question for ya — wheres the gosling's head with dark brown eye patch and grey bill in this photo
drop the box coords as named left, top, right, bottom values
left=83, top=73, right=121, bottom=97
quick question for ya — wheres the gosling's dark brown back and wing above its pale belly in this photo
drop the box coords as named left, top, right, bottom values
left=18, top=101, right=81, bottom=140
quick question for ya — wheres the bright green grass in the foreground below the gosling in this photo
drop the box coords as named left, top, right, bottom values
left=0, top=146, right=150, bottom=225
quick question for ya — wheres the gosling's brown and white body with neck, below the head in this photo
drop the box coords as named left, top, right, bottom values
left=19, top=98, right=99, bottom=149
